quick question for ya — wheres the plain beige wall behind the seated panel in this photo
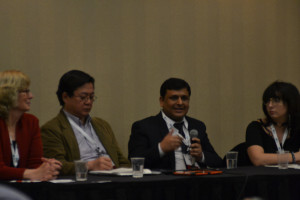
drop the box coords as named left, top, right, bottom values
left=0, top=0, right=300, bottom=159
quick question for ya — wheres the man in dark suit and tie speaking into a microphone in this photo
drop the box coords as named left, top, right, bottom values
left=128, top=78, right=222, bottom=170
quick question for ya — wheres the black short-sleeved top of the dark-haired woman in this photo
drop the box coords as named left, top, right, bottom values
left=246, top=120, right=300, bottom=153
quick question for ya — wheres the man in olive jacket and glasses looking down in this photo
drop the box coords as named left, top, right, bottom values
left=41, top=70, right=130, bottom=175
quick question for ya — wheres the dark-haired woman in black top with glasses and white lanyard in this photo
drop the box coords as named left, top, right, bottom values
left=246, top=81, right=300, bottom=166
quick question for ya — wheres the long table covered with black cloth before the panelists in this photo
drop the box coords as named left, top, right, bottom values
left=2, top=167, right=300, bottom=200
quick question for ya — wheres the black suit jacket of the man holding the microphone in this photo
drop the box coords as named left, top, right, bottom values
left=128, top=113, right=222, bottom=170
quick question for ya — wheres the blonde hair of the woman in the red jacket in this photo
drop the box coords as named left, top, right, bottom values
left=0, top=70, right=30, bottom=119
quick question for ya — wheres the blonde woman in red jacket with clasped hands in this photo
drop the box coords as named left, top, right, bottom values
left=0, top=70, right=61, bottom=181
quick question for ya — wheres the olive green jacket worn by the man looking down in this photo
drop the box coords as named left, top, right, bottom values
left=41, top=110, right=130, bottom=175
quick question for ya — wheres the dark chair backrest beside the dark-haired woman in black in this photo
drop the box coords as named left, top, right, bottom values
left=223, top=142, right=253, bottom=166
